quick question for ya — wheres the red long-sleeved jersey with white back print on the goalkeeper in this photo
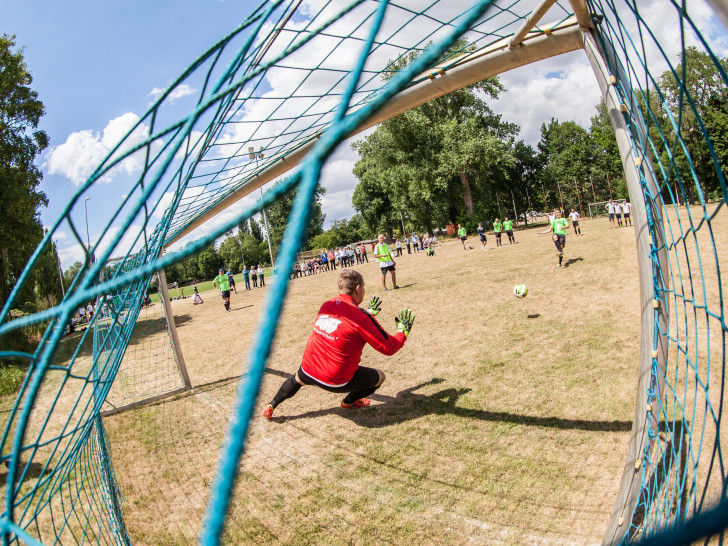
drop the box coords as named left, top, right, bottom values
left=301, top=294, right=407, bottom=387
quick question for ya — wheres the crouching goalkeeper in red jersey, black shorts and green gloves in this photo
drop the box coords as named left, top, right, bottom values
left=263, top=269, right=415, bottom=419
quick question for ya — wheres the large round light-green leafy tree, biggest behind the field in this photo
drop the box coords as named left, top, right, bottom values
left=352, top=41, right=518, bottom=231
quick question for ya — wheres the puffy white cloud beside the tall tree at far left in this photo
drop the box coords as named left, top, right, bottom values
left=46, top=112, right=152, bottom=186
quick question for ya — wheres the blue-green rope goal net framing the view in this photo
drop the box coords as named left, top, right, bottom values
left=0, top=0, right=728, bottom=544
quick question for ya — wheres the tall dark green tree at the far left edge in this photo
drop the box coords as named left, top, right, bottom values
left=0, top=35, right=48, bottom=307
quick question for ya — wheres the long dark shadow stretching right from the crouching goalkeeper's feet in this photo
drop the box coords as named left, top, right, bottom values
left=272, top=378, right=632, bottom=432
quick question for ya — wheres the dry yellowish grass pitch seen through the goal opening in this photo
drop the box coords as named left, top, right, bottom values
left=98, top=215, right=656, bottom=544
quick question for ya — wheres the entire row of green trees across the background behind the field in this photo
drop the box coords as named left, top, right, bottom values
left=0, top=35, right=728, bottom=313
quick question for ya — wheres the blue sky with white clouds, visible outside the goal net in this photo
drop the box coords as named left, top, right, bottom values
left=0, top=0, right=728, bottom=268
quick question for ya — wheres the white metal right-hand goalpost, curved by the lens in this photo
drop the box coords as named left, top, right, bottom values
left=584, top=33, right=669, bottom=544
